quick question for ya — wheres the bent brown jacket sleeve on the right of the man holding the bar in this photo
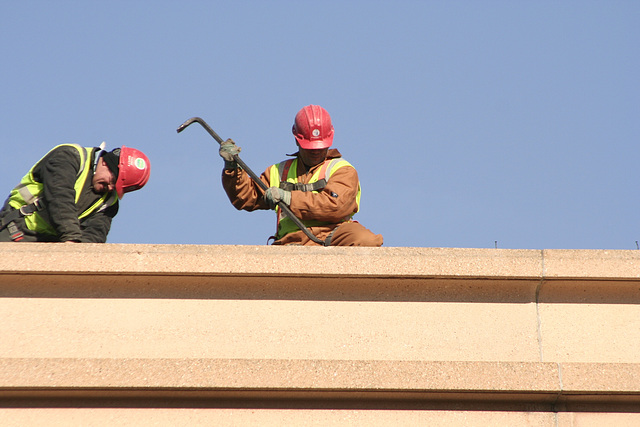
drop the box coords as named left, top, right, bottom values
left=289, top=166, right=359, bottom=222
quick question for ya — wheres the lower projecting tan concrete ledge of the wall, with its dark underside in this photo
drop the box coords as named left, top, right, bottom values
left=0, top=359, right=640, bottom=411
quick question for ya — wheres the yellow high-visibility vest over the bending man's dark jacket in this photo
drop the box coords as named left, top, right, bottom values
left=8, top=144, right=118, bottom=236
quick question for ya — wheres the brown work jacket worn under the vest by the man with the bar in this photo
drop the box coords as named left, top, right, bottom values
left=222, top=149, right=360, bottom=245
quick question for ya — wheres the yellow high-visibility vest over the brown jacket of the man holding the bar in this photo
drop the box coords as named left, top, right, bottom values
left=269, top=158, right=360, bottom=240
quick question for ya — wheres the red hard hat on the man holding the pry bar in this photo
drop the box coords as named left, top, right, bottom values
left=292, top=105, right=333, bottom=150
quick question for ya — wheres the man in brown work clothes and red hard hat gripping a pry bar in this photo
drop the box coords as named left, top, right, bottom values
left=220, top=105, right=382, bottom=246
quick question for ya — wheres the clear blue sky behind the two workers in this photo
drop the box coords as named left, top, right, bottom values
left=0, top=0, right=640, bottom=250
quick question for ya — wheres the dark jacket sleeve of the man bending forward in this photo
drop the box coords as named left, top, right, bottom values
left=34, top=147, right=82, bottom=242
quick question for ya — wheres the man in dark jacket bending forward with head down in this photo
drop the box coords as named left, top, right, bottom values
left=0, top=143, right=151, bottom=243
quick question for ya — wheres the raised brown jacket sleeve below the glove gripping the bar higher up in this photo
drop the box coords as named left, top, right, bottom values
left=222, top=167, right=270, bottom=211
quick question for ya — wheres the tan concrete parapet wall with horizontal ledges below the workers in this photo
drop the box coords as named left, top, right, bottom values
left=0, top=243, right=640, bottom=425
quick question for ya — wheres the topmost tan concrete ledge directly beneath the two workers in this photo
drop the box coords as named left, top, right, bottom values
left=0, top=243, right=640, bottom=280
